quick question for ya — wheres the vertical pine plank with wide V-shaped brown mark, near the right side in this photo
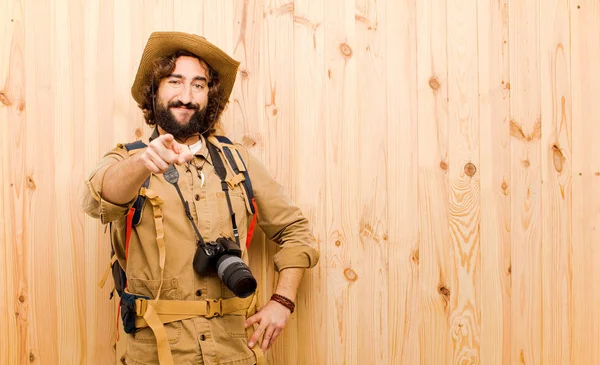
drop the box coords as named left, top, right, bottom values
left=508, top=1, right=545, bottom=364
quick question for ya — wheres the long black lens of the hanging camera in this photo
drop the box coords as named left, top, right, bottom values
left=215, top=255, right=256, bottom=298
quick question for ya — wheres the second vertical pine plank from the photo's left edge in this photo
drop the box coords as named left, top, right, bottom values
left=23, top=1, right=60, bottom=364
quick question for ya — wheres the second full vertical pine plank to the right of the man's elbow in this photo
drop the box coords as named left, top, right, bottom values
left=354, top=0, right=386, bottom=364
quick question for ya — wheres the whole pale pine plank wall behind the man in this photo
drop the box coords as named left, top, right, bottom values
left=0, top=0, right=600, bottom=365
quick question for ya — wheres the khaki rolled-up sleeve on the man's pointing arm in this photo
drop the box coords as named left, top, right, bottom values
left=82, top=145, right=135, bottom=224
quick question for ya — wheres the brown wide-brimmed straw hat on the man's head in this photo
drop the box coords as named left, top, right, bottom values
left=131, top=32, right=240, bottom=104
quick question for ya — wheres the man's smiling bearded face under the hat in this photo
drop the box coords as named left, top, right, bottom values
left=155, top=56, right=210, bottom=139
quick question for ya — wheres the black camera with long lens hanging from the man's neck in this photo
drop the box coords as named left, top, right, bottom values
left=194, top=237, right=256, bottom=298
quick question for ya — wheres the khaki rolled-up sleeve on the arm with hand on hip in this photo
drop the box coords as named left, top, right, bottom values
left=247, top=147, right=319, bottom=271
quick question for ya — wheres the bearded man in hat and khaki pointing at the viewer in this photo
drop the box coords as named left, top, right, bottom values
left=83, top=32, right=319, bottom=365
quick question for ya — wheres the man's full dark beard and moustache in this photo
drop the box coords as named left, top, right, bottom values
left=154, top=101, right=208, bottom=140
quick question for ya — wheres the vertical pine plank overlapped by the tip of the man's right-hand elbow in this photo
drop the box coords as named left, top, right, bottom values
left=291, top=0, right=328, bottom=364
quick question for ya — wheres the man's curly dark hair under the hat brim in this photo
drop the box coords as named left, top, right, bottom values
left=138, top=51, right=228, bottom=137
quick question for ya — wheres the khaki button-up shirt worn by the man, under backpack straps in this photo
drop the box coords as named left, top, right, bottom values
left=83, top=134, right=319, bottom=365
